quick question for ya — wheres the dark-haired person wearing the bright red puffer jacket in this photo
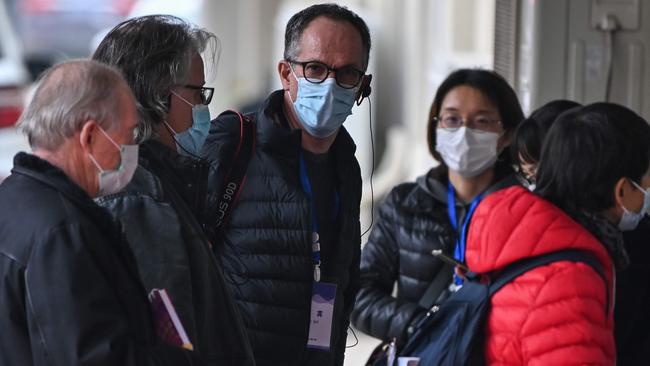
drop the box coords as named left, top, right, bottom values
left=466, top=103, right=650, bottom=365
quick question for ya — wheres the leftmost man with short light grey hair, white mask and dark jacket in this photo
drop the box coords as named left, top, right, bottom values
left=0, top=61, right=200, bottom=366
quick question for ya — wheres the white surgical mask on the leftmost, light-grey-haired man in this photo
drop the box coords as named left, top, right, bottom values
left=88, top=127, right=138, bottom=196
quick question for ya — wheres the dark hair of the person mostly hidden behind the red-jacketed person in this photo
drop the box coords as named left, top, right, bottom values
left=510, top=99, right=582, bottom=164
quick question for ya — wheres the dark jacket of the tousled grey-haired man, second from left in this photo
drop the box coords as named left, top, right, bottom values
left=96, top=141, right=253, bottom=366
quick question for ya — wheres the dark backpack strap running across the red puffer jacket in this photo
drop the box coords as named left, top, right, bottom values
left=489, top=249, right=609, bottom=314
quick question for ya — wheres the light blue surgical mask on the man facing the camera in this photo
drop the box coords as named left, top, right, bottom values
left=289, top=70, right=357, bottom=138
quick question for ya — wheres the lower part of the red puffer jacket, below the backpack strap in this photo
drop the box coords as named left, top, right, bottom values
left=486, top=261, right=615, bottom=365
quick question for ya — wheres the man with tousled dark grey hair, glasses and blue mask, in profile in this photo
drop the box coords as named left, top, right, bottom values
left=93, top=15, right=253, bottom=366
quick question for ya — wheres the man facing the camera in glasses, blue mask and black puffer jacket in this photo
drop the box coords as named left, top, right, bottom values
left=203, top=4, right=370, bottom=366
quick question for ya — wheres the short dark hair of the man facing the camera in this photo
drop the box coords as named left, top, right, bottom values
left=284, top=4, right=371, bottom=67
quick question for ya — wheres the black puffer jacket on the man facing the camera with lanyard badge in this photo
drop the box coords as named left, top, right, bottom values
left=203, top=91, right=361, bottom=366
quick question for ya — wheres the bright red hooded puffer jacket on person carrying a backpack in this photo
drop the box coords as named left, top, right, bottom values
left=466, top=187, right=616, bottom=366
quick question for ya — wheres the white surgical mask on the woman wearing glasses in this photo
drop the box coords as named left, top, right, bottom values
left=436, top=126, right=501, bottom=178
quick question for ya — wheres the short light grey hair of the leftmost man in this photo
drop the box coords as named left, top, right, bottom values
left=17, top=60, right=128, bottom=151
